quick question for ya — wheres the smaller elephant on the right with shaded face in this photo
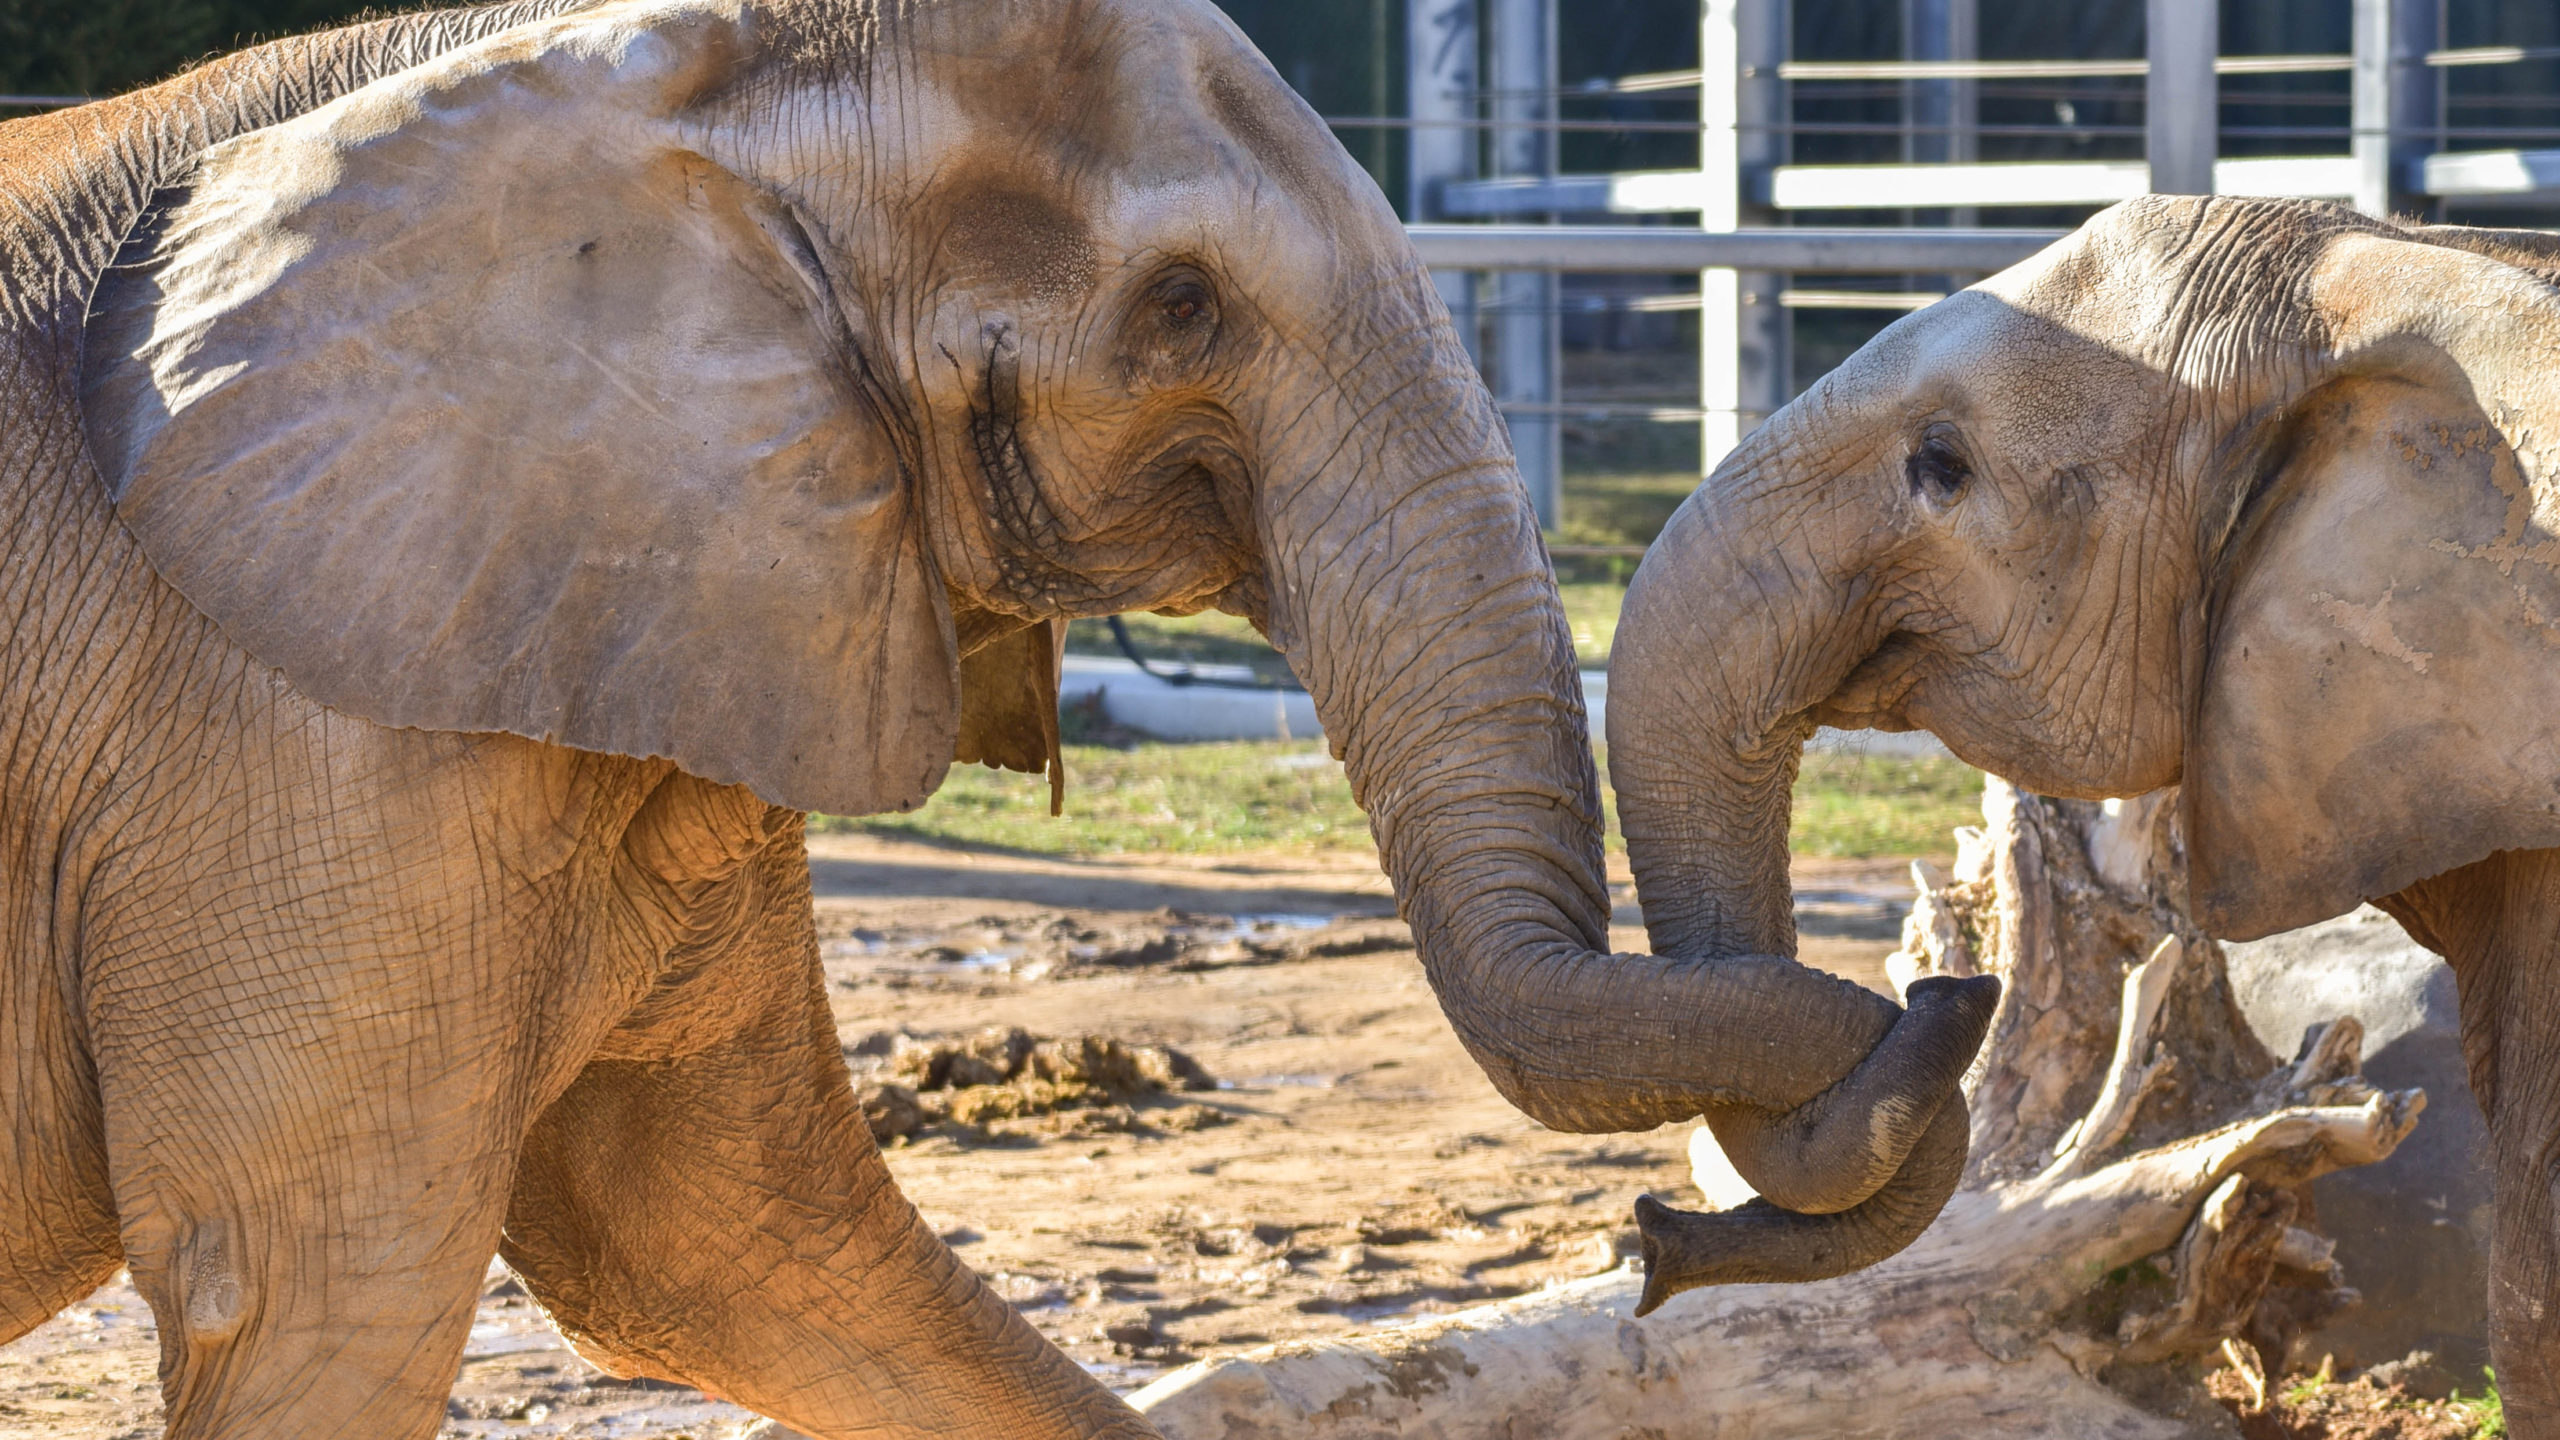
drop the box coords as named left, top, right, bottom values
left=1608, top=197, right=2560, bottom=1435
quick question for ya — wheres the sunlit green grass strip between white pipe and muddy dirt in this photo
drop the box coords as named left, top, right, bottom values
left=812, top=740, right=1981, bottom=858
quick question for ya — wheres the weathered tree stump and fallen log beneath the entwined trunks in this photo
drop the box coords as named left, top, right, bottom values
left=1137, top=779, right=2427, bottom=1440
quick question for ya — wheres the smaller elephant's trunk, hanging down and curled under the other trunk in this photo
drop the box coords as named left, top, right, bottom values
left=1610, top=430, right=1999, bottom=1304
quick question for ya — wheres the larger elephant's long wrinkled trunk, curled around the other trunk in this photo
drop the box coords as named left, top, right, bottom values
left=1262, top=278, right=1997, bottom=1263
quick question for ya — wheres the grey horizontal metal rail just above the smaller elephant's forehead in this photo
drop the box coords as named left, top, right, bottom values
left=1405, top=224, right=2068, bottom=274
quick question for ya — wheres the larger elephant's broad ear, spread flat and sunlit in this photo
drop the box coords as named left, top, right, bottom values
left=82, top=5, right=957, bottom=812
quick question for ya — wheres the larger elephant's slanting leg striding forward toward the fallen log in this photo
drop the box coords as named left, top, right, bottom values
left=502, top=835, right=1155, bottom=1440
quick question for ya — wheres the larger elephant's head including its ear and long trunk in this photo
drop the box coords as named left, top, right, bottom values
left=82, top=0, right=1981, bottom=1270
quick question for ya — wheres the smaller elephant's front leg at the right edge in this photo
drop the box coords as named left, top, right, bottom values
left=2381, top=851, right=2560, bottom=1440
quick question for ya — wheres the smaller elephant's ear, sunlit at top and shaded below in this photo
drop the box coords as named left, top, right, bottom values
left=2181, top=238, right=2560, bottom=938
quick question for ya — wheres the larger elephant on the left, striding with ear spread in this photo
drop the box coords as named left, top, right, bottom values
left=0, top=0, right=1992, bottom=1440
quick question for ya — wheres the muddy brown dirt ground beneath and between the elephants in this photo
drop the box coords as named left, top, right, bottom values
left=0, top=835, right=1910, bottom=1440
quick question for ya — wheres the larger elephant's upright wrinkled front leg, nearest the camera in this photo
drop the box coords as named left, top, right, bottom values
left=87, top=869, right=532, bottom=1440
